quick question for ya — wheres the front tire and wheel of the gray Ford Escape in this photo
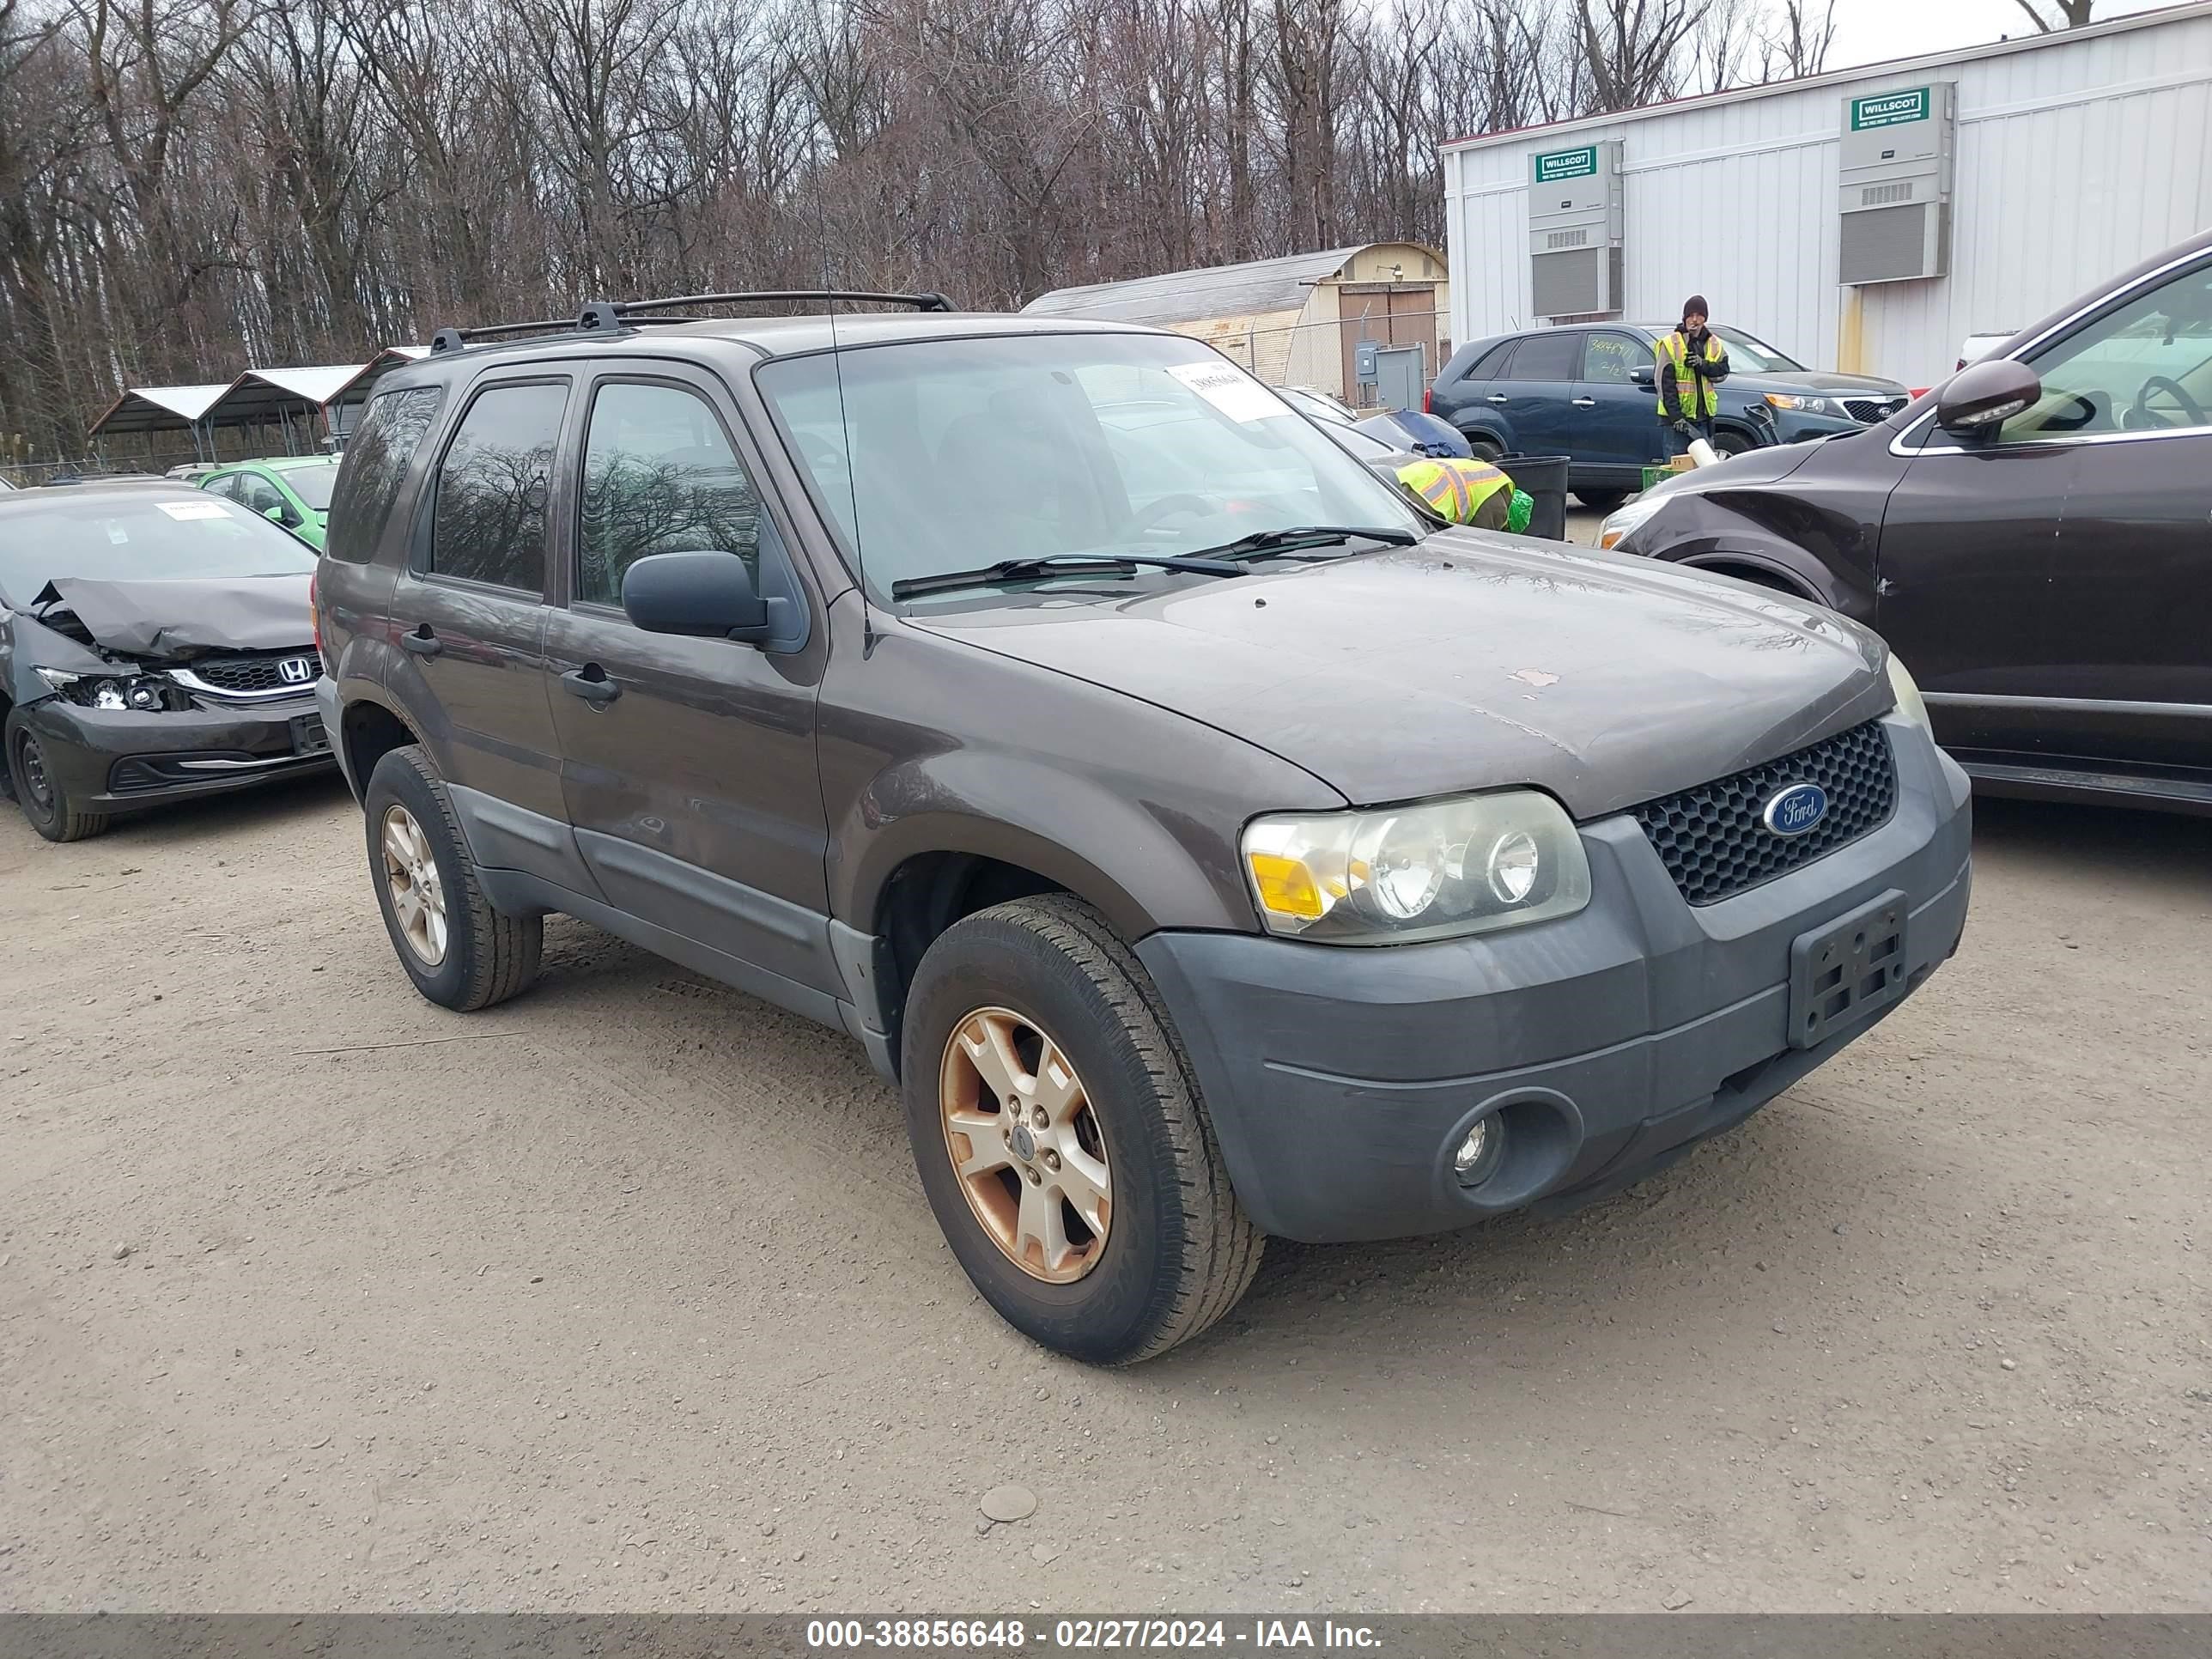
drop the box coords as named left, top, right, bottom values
left=902, top=894, right=1265, bottom=1364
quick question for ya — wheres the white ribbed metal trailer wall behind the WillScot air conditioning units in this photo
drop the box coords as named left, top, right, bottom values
left=1444, top=3, right=2212, bottom=385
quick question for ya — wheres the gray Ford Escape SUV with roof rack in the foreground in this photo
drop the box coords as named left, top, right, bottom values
left=316, top=296, right=1969, bottom=1360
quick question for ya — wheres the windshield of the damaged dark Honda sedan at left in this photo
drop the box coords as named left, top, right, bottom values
left=0, top=489, right=314, bottom=611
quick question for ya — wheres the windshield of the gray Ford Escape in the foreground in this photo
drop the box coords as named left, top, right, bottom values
left=754, top=334, right=1427, bottom=595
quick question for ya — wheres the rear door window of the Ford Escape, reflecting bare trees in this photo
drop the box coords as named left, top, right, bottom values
left=425, top=380, right=568, bottom=598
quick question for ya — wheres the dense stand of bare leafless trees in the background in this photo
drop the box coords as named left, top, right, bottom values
left=0, top=0, right=1867, bottom=462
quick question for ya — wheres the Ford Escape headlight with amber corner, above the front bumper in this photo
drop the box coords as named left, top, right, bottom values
left=1243, top=790, right=1590, bottom=945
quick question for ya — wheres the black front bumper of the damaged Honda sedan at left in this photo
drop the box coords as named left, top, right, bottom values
left=24, top=690, right=331, bottom=811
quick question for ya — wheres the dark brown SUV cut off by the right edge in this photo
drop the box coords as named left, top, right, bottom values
left=1604, top=232, right=2212, bottom=817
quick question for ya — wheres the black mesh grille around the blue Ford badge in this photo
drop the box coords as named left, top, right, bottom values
left=1635, top=721, right=1898, bottom=905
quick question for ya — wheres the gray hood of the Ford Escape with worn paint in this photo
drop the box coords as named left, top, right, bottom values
left=907, top=531, right=1893, bottom=818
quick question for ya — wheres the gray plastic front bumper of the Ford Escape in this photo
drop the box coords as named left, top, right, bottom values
left=1137, top=719, right=1971, bottom=1243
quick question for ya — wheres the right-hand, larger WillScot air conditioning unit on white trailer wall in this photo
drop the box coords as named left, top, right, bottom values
left=1838, top=82, right=1958, bottom=288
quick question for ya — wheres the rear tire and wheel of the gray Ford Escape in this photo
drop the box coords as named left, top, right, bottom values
left=362, top=744, right=544, bottom=1013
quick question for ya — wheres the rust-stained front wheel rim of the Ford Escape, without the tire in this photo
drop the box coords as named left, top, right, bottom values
left=938, top=1009, right=1113, bottom=1285
